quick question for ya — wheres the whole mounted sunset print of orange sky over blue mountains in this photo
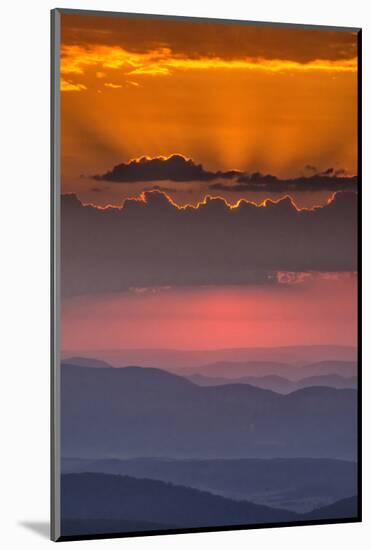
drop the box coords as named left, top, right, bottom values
left=52, top=10, right=361, bottom=540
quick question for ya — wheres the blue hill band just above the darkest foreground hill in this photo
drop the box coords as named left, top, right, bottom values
left=62, top=458, right=357, bottom=512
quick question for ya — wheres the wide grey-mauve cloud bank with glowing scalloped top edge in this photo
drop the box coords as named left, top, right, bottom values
left=61, top=191, right=357, bottom=297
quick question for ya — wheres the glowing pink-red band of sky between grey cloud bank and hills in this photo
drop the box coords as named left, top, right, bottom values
left=63, top=274, right=357, bottom=352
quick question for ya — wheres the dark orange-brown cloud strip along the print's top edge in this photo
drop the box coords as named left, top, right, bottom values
left=62, top=15, right=357, bottom=63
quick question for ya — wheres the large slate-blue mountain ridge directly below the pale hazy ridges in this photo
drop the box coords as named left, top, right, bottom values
left=61, top=365, right=357, bottom=459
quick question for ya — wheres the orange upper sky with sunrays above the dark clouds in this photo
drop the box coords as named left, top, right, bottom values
left=61, top=15, right=357, bottom=210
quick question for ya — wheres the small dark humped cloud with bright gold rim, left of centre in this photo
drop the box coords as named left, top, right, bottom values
left=93, top=155, right=241, bottom=183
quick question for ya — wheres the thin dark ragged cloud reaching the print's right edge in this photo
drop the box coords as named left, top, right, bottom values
left=209, top=175, right=357, bottom=193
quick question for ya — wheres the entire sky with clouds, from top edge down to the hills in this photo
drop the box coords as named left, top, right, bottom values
left=60, top=15, right=358, bottom=351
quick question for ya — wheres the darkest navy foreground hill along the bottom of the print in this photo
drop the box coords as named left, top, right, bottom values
left=61, top=473, right=357, bottom=535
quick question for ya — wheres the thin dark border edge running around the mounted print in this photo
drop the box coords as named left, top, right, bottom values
left=50, top=8, right=362, bottom=542
